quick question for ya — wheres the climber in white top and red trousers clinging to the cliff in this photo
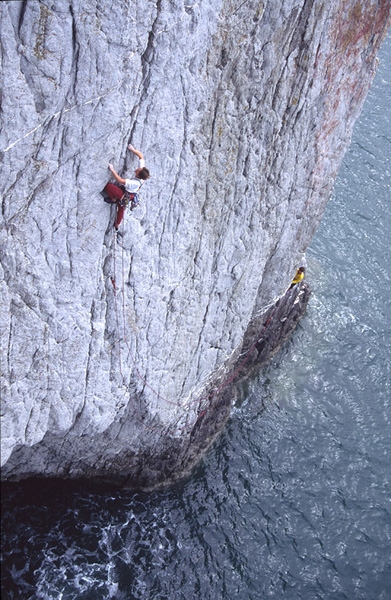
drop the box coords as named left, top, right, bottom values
left=103, top=144, right=150, bottom=231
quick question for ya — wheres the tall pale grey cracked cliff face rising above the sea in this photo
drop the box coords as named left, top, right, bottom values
left=0, top=0, right=391, bottom=486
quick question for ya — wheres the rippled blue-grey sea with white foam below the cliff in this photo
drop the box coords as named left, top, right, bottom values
left=1, top=36, right=391, bottom=600
